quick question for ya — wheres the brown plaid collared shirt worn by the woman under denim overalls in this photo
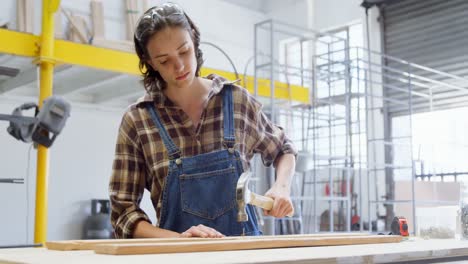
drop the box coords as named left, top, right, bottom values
left=109, top=75, right=297, bottom=238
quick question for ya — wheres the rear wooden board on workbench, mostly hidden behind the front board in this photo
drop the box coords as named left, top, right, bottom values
left=45, top=233, right=368, bottom=251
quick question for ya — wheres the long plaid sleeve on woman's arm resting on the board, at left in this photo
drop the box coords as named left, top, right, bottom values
left=109, top=112, right=151, bottom=238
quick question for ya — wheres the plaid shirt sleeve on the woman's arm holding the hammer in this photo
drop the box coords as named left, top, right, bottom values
left=251, top=97, right=297, bottom=166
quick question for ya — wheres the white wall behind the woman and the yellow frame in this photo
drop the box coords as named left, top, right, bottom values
left=0, top=0, right=266, bottom=245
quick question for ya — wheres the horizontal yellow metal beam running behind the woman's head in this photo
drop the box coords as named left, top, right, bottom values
left=0, top=29, right=309, bottom=104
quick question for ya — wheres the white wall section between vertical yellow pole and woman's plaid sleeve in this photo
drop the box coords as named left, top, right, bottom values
left=48, top=106, right=122, bottom=239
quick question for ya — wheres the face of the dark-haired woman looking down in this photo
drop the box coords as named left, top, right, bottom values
left=146, top=27, right=197, bottom=89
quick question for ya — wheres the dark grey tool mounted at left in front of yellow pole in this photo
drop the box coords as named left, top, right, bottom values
left=0, top=96, right=70, bottom=148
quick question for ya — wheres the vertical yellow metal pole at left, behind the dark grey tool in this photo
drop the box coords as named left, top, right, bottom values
left=34, top=0, right=60, bottom=244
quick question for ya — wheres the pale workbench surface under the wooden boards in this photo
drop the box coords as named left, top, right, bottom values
left=0, top=238, right=468, bottom=264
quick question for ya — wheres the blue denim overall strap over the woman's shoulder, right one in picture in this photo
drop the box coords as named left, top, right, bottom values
left=223, top=84, right=236, bottom=148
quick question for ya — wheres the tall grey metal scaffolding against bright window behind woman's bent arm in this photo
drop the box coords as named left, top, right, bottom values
left=254, top=20, right=362, bottom=233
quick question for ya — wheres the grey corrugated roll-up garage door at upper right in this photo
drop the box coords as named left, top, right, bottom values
left=380, top=0, right=468, bottom=116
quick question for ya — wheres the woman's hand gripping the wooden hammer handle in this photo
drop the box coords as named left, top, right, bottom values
left=263, top=184, right=294, bottom=218
